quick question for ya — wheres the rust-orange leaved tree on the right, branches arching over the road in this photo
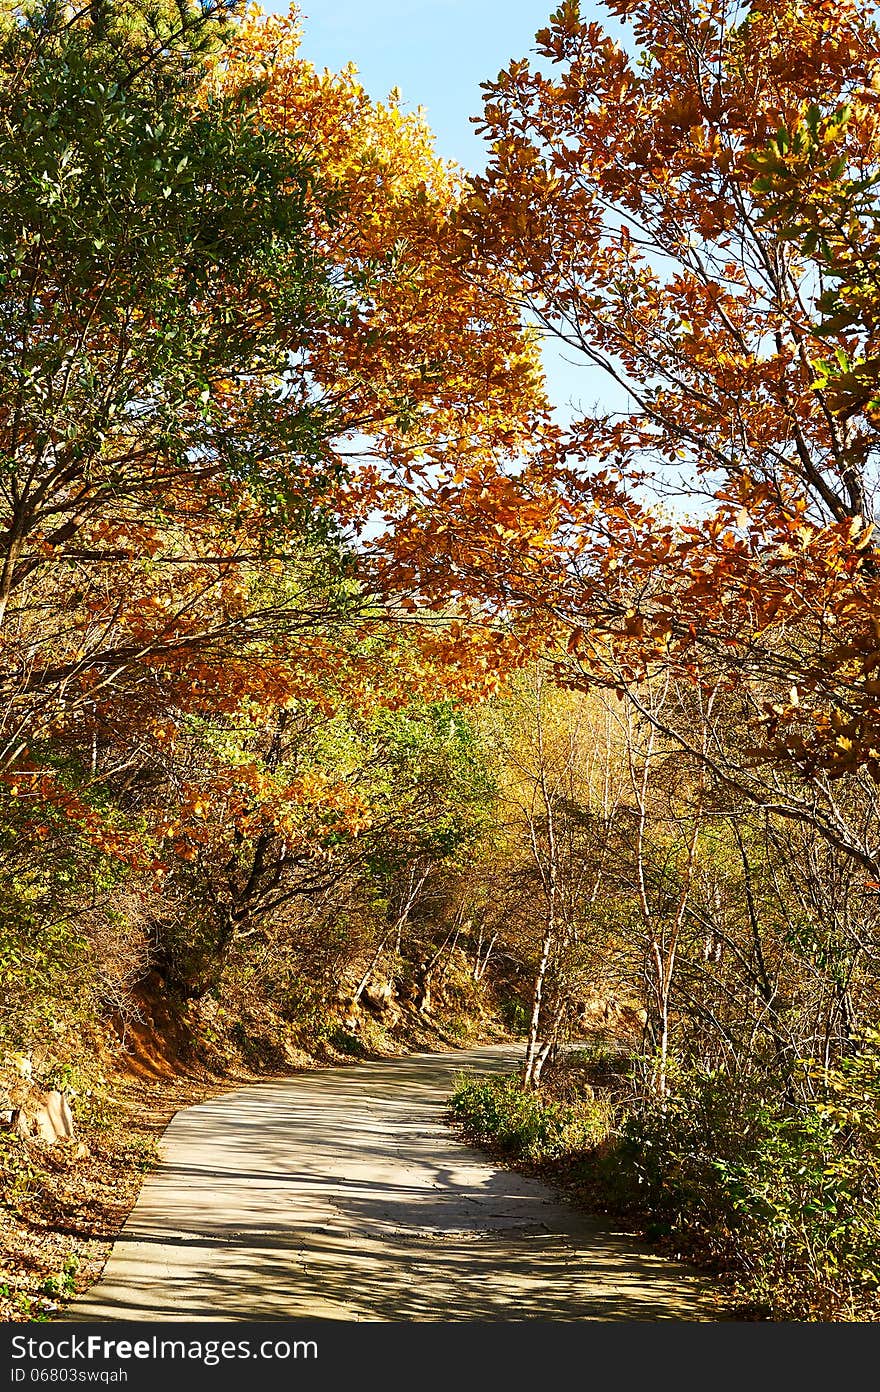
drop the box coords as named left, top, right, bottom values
left=356, top=3, right=880, bottom=873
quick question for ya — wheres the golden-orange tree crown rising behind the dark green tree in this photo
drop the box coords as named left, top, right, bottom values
left=220, top=8, right=543, bottom=489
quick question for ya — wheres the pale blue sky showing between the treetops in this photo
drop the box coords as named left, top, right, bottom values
left=262, top=0, right=620, bottom=418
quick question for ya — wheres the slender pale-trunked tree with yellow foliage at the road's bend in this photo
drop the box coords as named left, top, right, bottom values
left=483, top=660, right=635, bottom=1087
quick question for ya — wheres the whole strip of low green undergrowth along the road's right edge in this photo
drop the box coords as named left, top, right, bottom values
left=450, top=1037, right=880, bottom=1321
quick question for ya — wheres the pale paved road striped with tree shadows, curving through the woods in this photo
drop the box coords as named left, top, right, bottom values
left=67, top=1047, right=718, bottom=1321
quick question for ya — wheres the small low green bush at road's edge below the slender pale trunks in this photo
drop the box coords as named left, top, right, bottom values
left=450, top=1076, right=610, bottom=1161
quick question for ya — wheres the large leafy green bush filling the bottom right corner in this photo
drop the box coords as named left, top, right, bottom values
left=615, top=1036, right=880, bottom=1320
